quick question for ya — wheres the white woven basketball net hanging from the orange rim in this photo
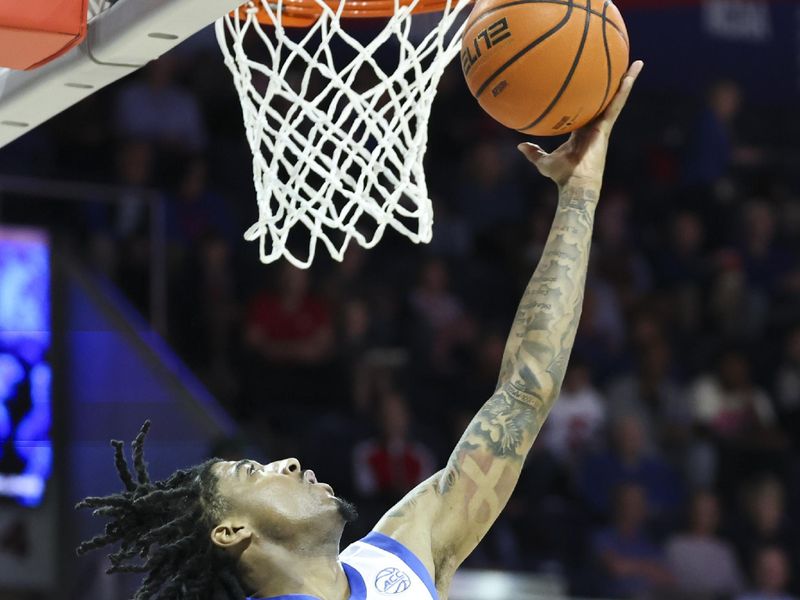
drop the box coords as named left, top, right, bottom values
left=216, top=0, right=471, bottom=268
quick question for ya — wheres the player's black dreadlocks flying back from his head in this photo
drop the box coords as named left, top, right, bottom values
left=75, top=421, right=246, bottom=600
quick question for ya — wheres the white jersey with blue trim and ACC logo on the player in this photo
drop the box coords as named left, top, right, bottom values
left=248, top=531, right=439, bottom=600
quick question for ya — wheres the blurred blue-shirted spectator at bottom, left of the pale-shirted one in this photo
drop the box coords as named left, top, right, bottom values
left=592, top=484, right=672, bottom=598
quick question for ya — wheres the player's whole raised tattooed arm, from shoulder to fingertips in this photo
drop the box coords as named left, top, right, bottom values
left=377, top=62, right=642, bottom=596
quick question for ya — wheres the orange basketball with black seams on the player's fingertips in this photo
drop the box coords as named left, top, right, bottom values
left=461, top=0, right=629, bottom=136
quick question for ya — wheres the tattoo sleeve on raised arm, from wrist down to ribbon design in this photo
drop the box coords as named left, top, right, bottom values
left=436, top=188, right=598, bottom=528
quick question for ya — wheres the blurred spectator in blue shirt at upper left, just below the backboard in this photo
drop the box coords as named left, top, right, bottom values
left=114, top=54, right=206, bottom=152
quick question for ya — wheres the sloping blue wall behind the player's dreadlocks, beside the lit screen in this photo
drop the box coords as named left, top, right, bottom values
left=64, top=267, right=234, bottom=600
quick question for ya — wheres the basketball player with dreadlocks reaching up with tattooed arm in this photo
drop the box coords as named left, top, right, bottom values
left=78, top=61, right=642, bottom=600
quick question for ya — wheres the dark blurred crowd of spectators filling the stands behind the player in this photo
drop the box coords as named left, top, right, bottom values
left=0, top=15, right=800, bottom=599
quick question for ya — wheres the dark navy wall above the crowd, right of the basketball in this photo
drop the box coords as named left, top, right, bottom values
left=616, top=0, right=800, bottom=102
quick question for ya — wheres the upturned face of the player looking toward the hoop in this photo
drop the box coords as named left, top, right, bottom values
left=213, top=458, right=342, bottom=539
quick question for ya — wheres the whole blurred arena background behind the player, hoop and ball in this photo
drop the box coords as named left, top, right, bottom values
left=0, top=0, right=800, bottom=600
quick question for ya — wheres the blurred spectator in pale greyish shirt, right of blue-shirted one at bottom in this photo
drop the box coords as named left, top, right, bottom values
left=667, top=492, right=743, bottom=600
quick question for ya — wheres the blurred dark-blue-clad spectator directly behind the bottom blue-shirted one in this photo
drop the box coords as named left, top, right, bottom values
left=579, top=414, right=683, bottom=523
